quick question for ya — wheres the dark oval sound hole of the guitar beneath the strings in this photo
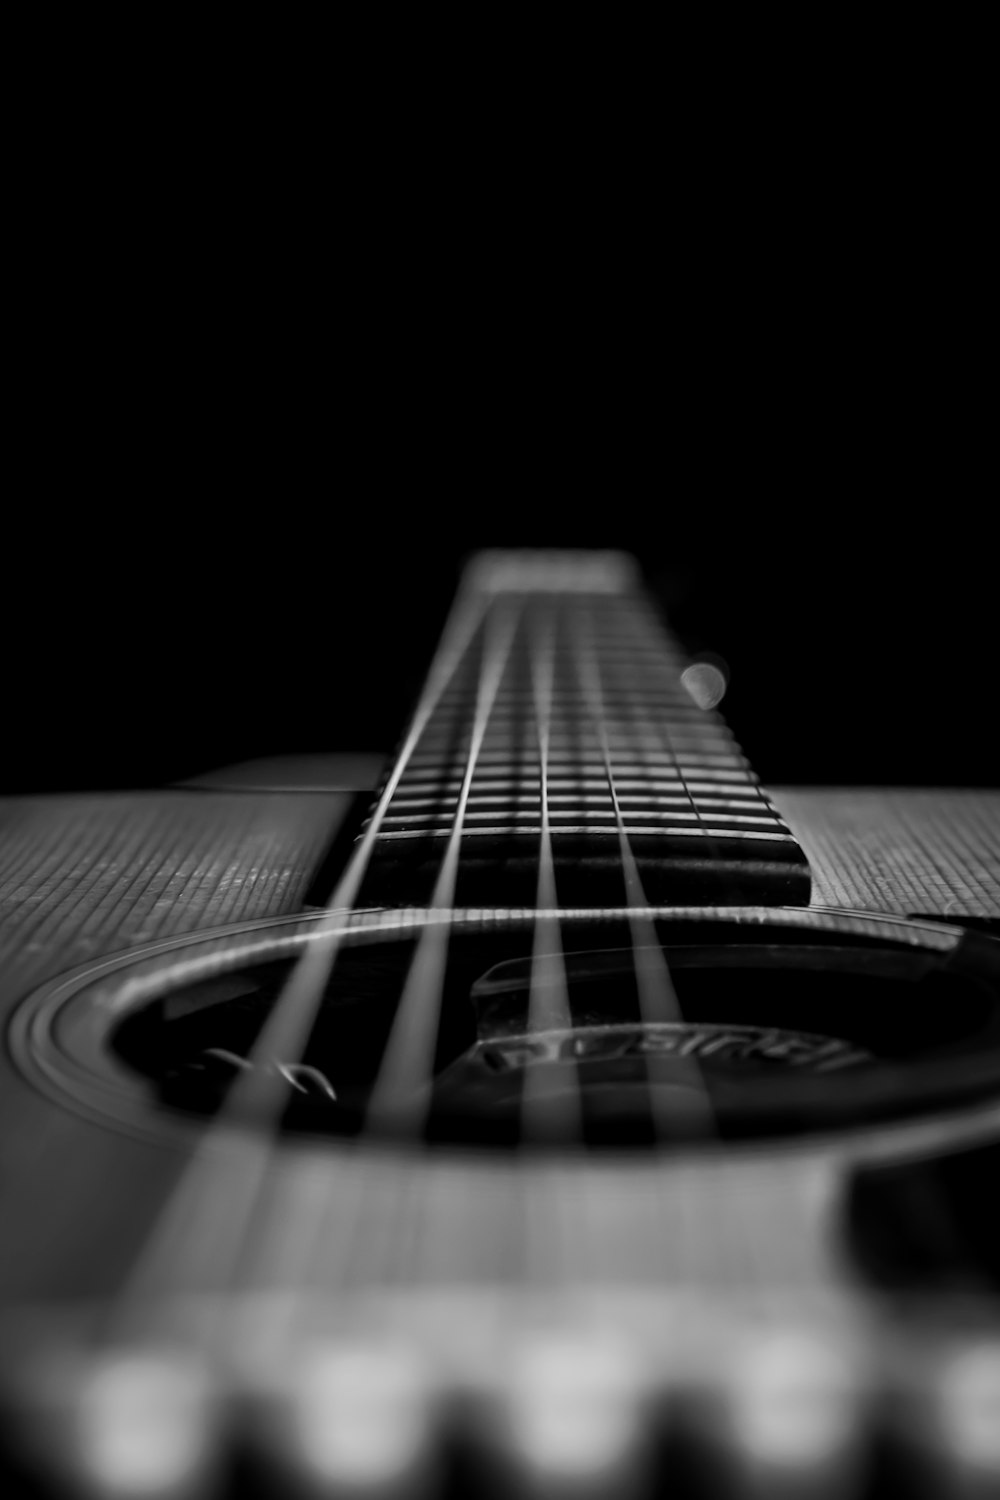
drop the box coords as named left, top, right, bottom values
left=108, top=929, right=1000, bottom=1148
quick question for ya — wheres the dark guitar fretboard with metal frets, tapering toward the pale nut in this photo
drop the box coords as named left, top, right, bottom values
left=361, top=554, right=810, bottom=906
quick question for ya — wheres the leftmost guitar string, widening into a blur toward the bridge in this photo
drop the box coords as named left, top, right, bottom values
left=105, top=579, right=489, bottom=1344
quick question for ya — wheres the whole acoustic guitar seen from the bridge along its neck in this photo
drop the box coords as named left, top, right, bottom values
left=0, top=552, right=1000, bottom=1500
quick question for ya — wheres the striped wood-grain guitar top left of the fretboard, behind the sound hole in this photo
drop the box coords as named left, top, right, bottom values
left=0, top=791, right=349, bottom=996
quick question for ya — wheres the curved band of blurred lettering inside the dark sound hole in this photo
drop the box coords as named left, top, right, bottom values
left=480, top=1022, right=874, bottom=1073
